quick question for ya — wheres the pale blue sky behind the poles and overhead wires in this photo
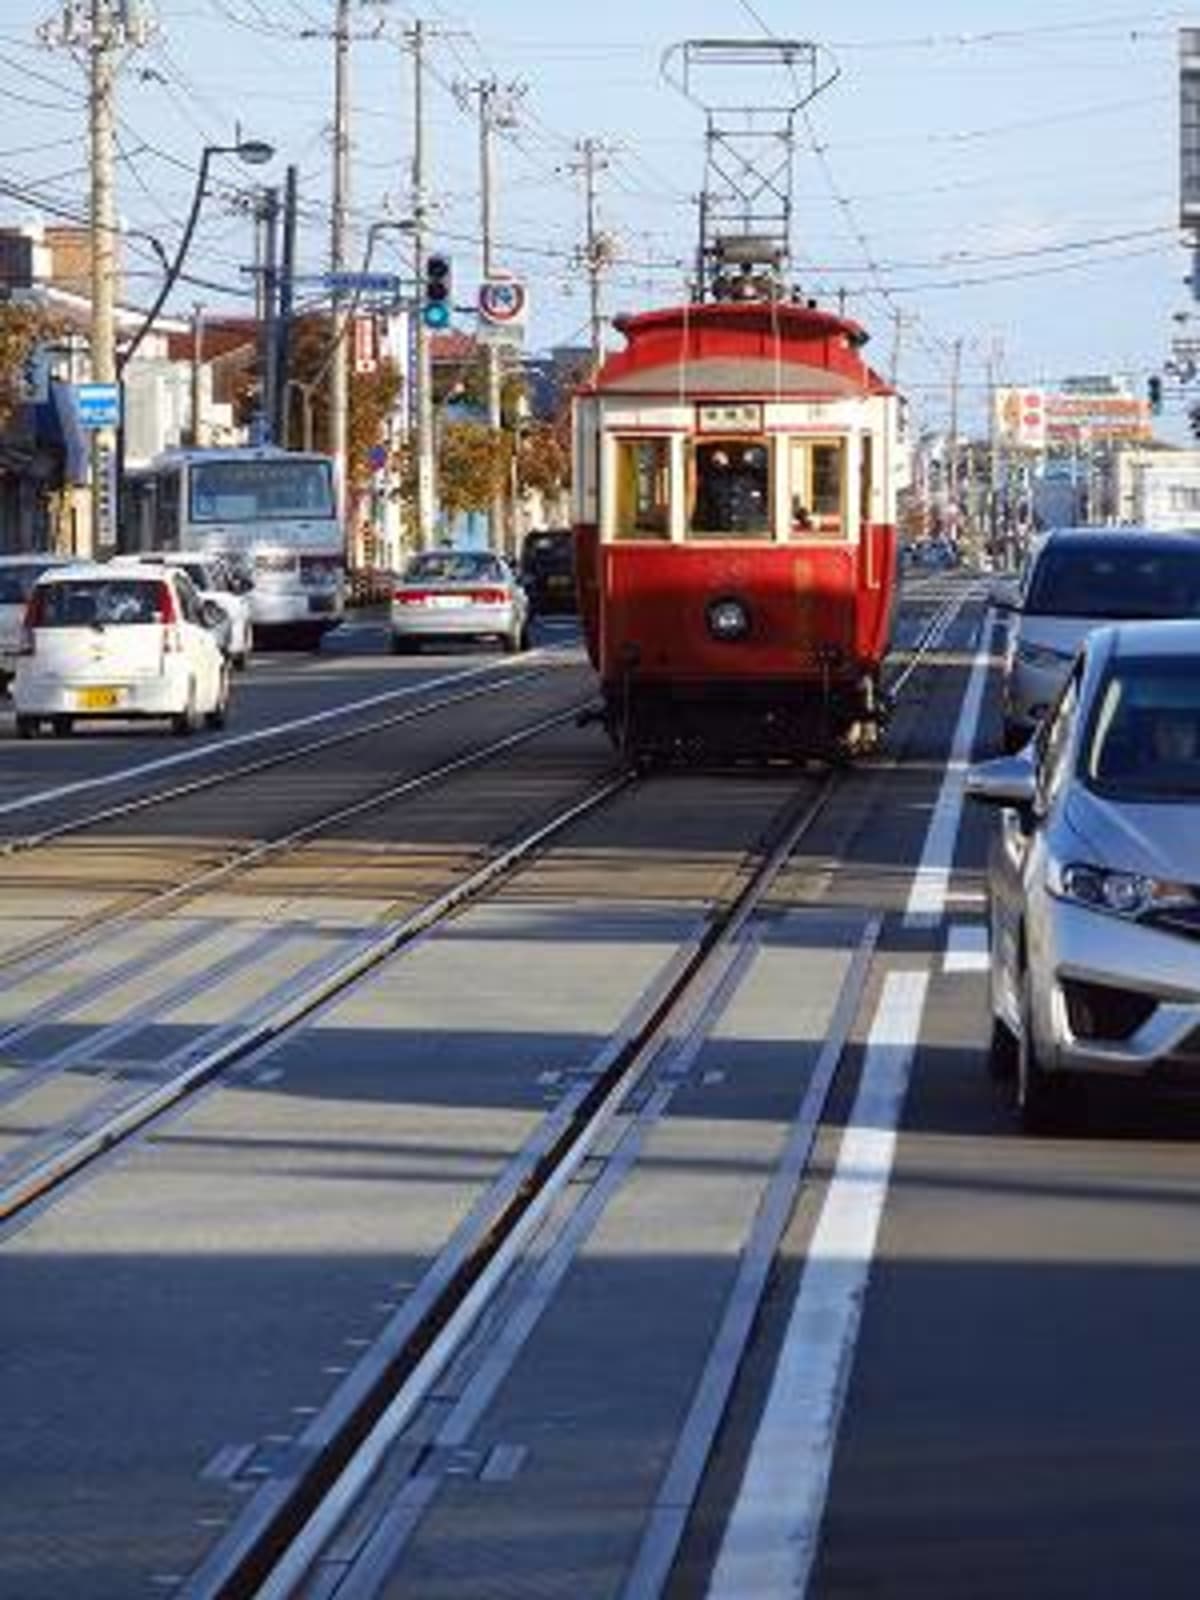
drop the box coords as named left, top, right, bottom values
left=0, top=0, right=1195, bottom=434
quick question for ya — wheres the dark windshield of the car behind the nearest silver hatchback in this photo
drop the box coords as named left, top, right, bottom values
left=1024, top=539, right=1200, bottom=621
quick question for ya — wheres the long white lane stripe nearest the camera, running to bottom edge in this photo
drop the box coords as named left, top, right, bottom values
left=709, top=973, right=930, bottom=1600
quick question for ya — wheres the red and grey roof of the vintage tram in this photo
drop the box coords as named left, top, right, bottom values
left=584, top=301, right=894, bottom=398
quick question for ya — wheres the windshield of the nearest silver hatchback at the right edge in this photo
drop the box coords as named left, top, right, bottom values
left=1083, top=656, right=1200, bottom=802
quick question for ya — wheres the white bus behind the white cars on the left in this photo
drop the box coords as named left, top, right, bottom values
left=123, top=446, right=346, bottom=645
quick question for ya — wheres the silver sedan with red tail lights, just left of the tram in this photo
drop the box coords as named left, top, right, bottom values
left=390, top=550, right=530, bottom=654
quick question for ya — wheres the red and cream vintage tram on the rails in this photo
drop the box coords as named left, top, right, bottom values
left=574, top=296, right=902, bottom=760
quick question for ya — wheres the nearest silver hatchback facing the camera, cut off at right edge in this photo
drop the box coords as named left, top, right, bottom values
left=966, top=622, right=1200, bottom=1130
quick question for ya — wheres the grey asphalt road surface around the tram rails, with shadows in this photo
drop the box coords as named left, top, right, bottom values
left=0, top=578, right=1200, bottom=1600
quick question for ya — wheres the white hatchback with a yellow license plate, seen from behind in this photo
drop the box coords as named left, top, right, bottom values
left=13, top=562, right=229, bottom=739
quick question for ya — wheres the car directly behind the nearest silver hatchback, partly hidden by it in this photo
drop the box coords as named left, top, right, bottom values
left=992, top=528, right=1200, bottom=750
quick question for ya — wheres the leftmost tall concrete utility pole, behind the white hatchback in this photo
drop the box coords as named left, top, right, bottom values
left=38, top=0, right=150, bottom=555
